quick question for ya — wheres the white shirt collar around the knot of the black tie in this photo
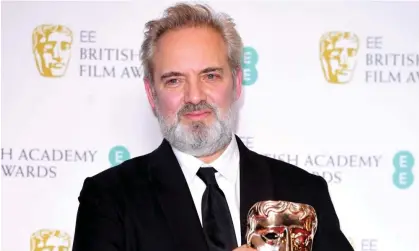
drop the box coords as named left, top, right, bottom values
left=172, top=135, right=240, bottom=184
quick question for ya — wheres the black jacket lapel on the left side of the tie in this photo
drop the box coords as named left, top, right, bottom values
left=150, top=140, right=207, bottom=251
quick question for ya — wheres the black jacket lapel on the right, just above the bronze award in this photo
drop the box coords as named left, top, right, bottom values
left=236, top=137, right=274, bottom=245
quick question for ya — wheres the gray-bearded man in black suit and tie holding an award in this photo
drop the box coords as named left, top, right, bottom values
left=73, top=4, right=353, bottom=251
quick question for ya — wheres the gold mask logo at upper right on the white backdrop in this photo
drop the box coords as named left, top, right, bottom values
left=320, top=31, right=359, bottom=84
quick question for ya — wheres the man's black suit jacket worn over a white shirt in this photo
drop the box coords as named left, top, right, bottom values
left=73, top=137, right=353, bottom=251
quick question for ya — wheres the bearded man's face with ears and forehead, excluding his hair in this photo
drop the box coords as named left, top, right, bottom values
left=146, top=27, right=241, bottom=157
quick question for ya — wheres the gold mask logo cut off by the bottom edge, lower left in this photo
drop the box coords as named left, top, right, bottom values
left=31, top=229, right=71, bottom=251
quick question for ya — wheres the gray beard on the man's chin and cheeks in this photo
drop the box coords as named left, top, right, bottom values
left=156, top=102, right=236, bottom=157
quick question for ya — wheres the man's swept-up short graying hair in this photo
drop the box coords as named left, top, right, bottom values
left=141, top=3, right=243, bottom=82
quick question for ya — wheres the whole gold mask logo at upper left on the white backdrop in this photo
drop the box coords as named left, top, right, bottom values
left=32, top=24, right=73, bottom=77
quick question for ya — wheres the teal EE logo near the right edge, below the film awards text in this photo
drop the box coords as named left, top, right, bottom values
left=393, top=151, right=415, bottom=189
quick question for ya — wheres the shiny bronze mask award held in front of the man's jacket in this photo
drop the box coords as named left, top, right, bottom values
left=246, top=201, right=317, bottom=251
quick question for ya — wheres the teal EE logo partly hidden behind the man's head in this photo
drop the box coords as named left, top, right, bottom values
left=242, top=47, right=259, bottom=85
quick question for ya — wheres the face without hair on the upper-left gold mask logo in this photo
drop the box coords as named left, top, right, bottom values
left=37, top=32, right=71, bottom=77
